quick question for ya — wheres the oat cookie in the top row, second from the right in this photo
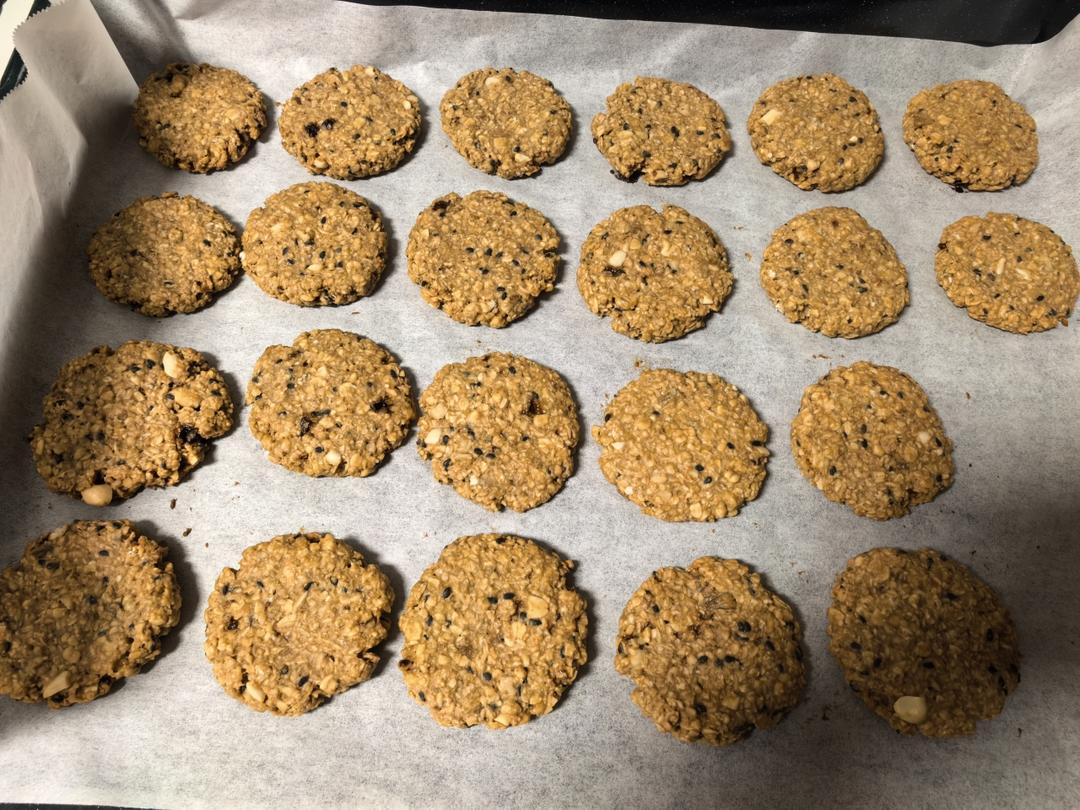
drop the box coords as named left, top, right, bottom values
left=746, top=73, right=885, bottom=191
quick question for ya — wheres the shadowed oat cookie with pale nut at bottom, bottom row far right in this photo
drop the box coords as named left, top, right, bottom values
left=828, top=549, right=1020, bottom=737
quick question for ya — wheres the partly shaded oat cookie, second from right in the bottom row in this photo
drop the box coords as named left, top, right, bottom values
left=615, top=557, right=806, bottom=745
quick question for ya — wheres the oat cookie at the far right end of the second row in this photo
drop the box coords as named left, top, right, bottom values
left=934, top=213, right=1080, bottom=335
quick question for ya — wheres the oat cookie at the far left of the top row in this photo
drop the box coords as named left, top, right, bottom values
left=134, top=63, right=267, bottom=174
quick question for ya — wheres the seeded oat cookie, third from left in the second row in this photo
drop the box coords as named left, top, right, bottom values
left=405, top=191, right=559, bottom=328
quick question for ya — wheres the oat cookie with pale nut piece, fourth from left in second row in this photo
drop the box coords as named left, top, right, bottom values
left=578, top=205, right=734, bottom=342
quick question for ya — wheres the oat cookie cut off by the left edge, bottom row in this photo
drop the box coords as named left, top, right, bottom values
left=0, top=521, right=180, bottom=708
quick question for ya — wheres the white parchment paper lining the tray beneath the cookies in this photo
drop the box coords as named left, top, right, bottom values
left=0, top=0, right=1080, bottom=808
